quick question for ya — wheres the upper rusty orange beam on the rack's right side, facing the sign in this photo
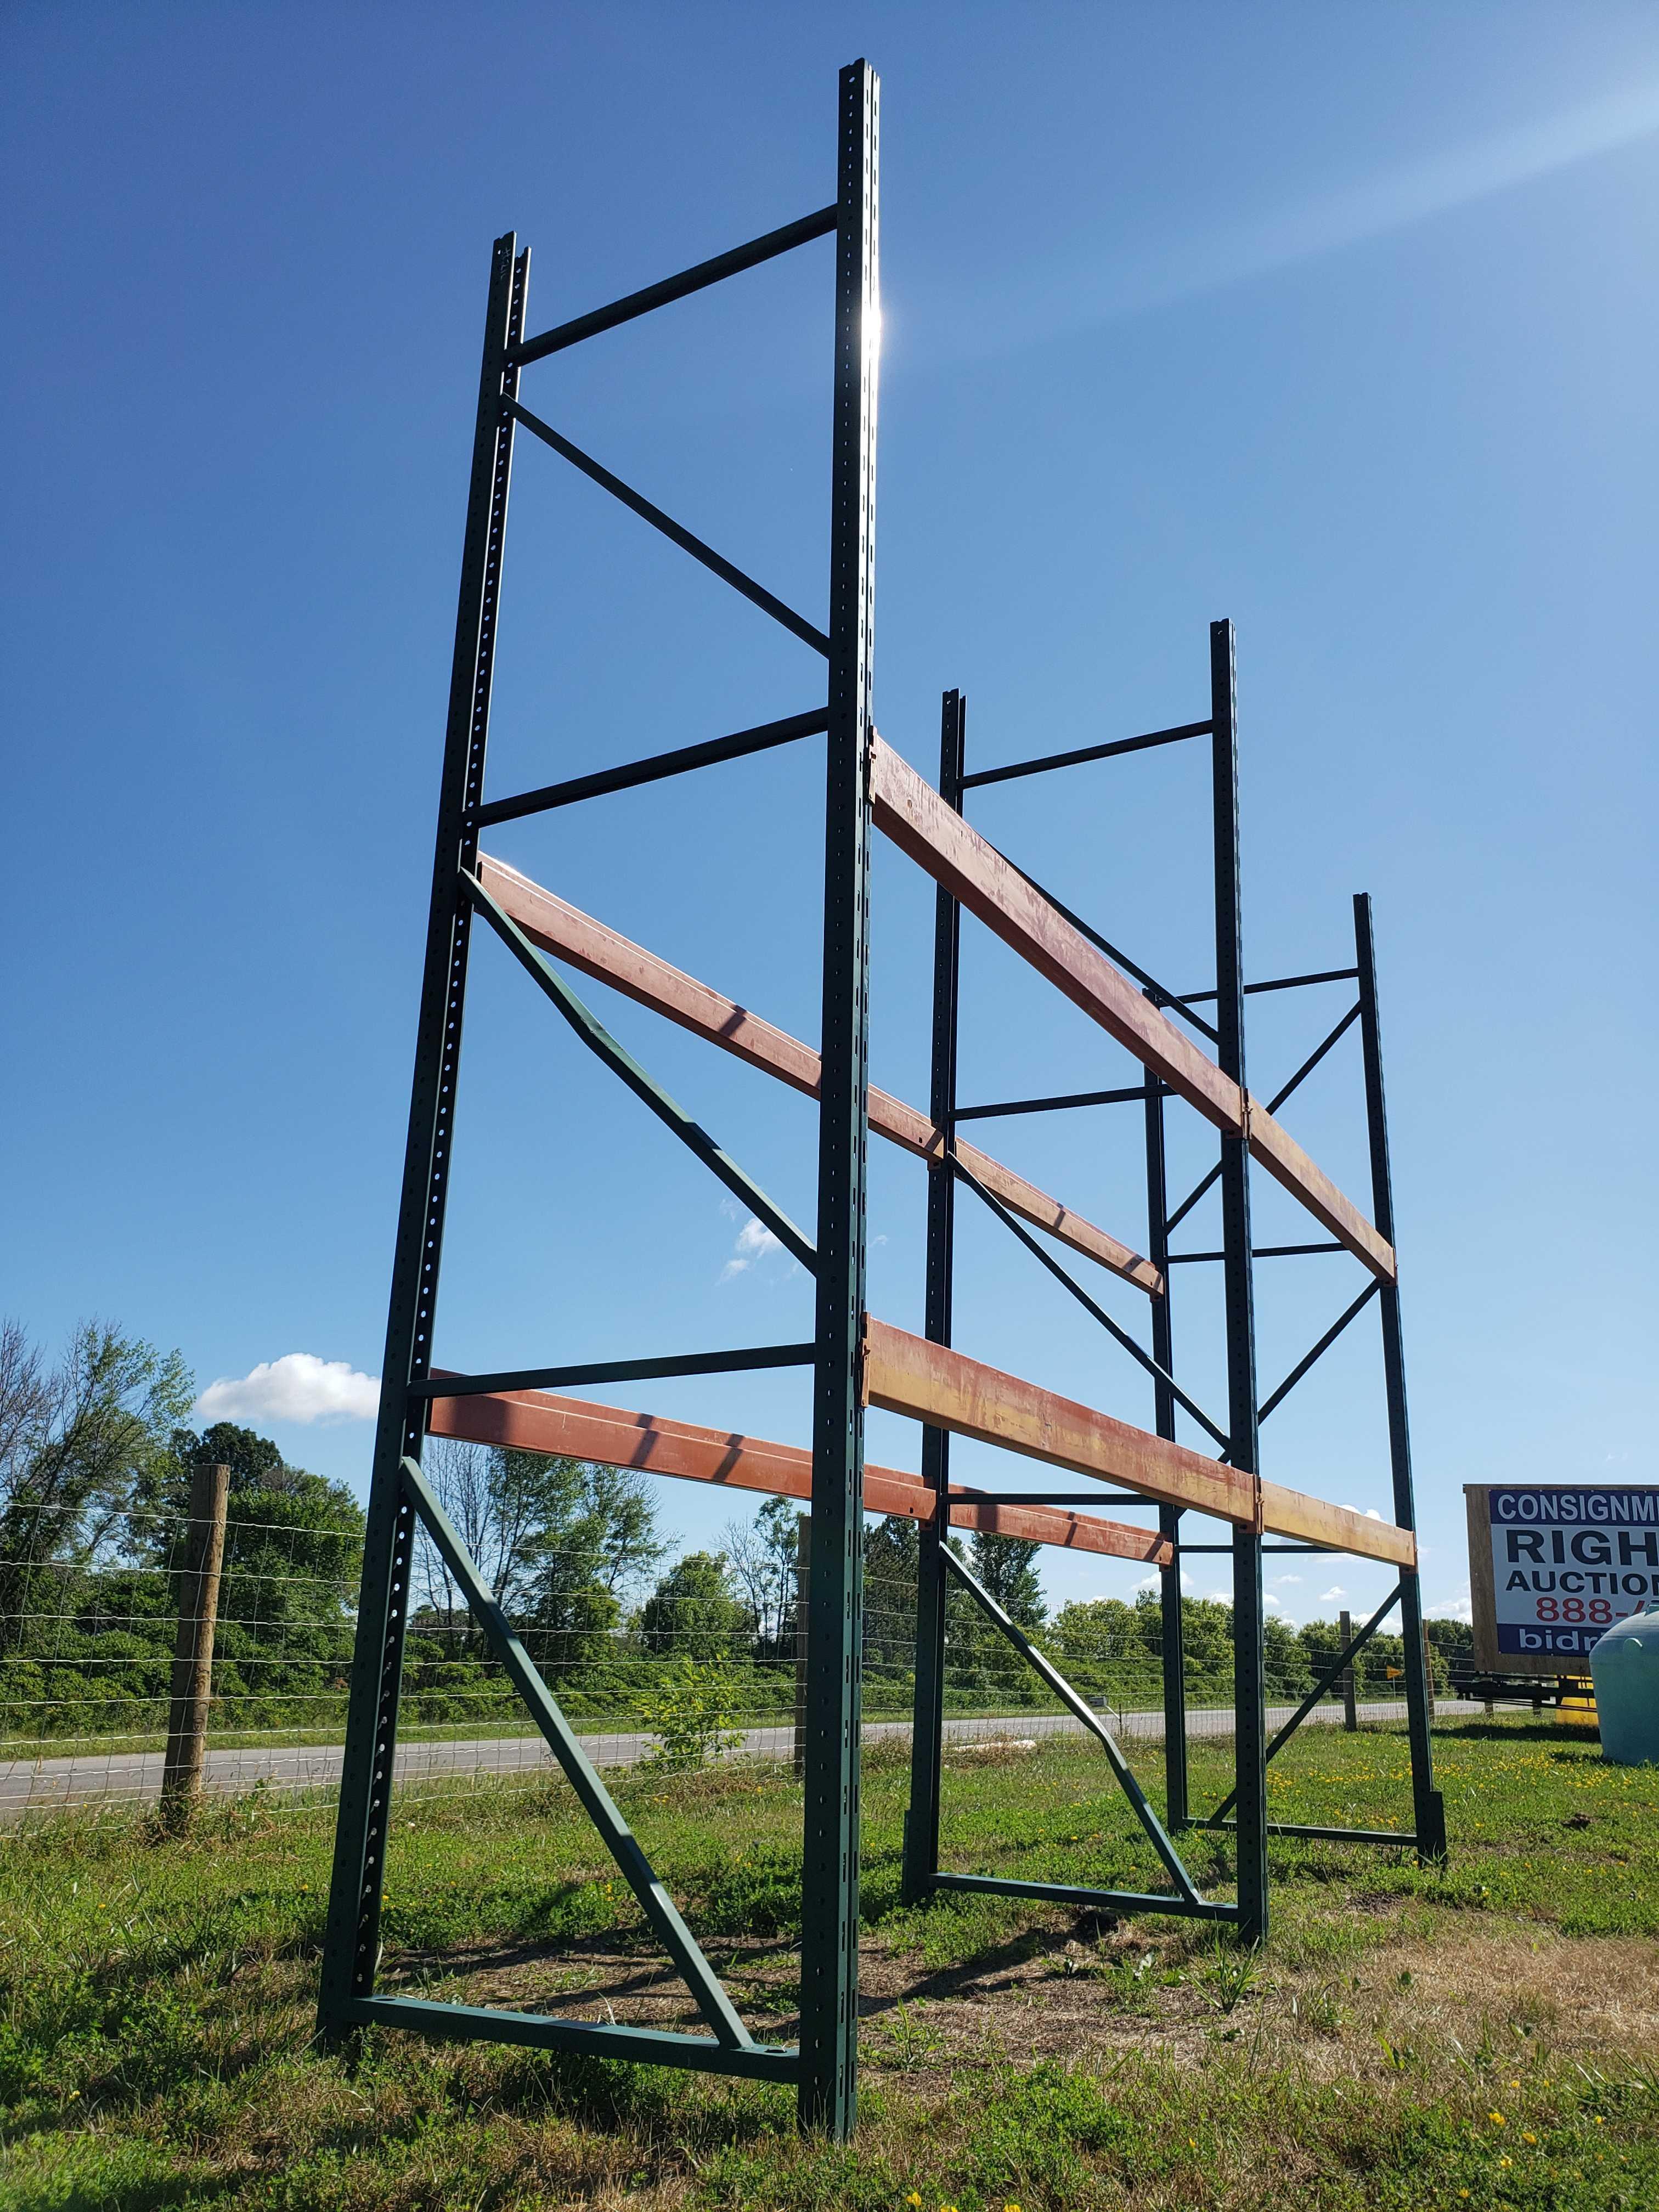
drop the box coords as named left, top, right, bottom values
left=870, top=737, right=1396, bottom=1283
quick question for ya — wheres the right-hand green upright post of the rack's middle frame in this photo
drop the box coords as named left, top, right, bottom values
left=1210, top=622, right=1267, bottom=1942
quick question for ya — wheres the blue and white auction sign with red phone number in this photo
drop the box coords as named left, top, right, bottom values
left=1464, top=1482, right=1659, bottom=1674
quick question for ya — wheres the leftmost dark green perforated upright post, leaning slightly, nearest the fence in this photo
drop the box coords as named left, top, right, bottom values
left=319, top=232, right=531, bottom=2042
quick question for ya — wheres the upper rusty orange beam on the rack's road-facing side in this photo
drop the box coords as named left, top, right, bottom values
left=478, top=856, right=1164, bottom=1296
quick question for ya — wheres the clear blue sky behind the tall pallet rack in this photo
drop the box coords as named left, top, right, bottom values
left=0, top=0, right=1659, bottom=1617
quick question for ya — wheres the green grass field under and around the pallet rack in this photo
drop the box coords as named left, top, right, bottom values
left=0, top=1721, right=1659, bottom=2212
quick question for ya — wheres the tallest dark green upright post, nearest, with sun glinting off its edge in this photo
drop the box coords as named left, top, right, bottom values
left=801, top=62, right=881, bottom=2139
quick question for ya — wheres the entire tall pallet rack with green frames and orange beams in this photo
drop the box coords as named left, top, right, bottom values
left=319, top=47, right=1438, bottom=2137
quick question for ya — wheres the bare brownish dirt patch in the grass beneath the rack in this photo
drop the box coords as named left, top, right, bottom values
left=393, top=1898, right=1659, bottom=2084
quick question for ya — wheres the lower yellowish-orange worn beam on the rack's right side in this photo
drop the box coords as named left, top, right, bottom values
left=865, top=1318, right=1418, bottom=1566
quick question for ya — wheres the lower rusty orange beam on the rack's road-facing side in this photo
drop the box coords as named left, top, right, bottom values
left=429, top=1391, right=1172, bottom=1566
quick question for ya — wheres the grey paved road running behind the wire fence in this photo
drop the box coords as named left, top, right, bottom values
left=0, top=1703, right=1402, bottom=1822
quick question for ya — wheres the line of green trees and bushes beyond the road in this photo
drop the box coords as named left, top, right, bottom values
left=0, top=1323, right=1469, bottom=1739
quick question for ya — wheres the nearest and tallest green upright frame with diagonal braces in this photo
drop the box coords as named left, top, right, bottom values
left=319, top=62, right=881, bottom=2137
